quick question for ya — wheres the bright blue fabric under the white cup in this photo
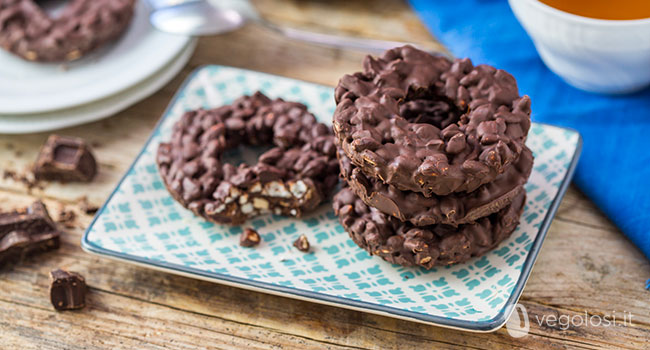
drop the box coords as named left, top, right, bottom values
left=410, top=0, right=650, bottom=258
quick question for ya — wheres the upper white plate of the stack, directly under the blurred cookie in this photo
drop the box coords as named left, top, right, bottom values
left=0, top=0, right=191, bottom=114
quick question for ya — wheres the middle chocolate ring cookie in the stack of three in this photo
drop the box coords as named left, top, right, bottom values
left=338, top=146, right=533, bottom=226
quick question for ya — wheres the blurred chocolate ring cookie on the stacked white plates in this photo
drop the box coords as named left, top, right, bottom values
left=0, top=0, right=136, bottom=62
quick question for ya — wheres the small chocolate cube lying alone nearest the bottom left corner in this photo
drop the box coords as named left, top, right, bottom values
left=50, top=269, right=86, bottom=310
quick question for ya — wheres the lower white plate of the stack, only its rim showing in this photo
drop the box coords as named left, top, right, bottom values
left=0, top=41, right=196, bottom=134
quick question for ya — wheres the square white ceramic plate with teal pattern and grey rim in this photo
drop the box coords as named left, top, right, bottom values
left=82, top=66, right=581, bottom=332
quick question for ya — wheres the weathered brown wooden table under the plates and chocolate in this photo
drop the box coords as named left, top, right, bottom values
left=0, top=0, right=650, bottom=349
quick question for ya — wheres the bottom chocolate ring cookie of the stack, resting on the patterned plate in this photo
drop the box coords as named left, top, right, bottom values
left=334, top=187, right=526, bottom=269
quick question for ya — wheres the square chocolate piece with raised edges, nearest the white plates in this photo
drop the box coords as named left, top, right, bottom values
left=33, top=135, right=97, bottom=182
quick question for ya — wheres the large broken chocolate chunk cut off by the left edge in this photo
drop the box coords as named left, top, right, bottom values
left=0, top=202, right=60, bottom=267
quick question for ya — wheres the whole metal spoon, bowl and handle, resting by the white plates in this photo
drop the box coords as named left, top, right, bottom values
left=149, top=0, right=447, bottom=55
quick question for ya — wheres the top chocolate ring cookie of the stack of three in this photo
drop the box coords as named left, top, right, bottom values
left=333, top=46, right=530, bottom=196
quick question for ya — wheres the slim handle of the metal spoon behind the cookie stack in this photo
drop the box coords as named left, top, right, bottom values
left=258, top=19, right=451, bottom=58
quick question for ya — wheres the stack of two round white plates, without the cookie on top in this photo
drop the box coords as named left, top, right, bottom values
left=0, top=1, right=196, bottom=134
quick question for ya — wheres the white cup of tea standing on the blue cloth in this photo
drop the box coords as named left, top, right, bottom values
left=508, top=0, right=650, bottom=94
